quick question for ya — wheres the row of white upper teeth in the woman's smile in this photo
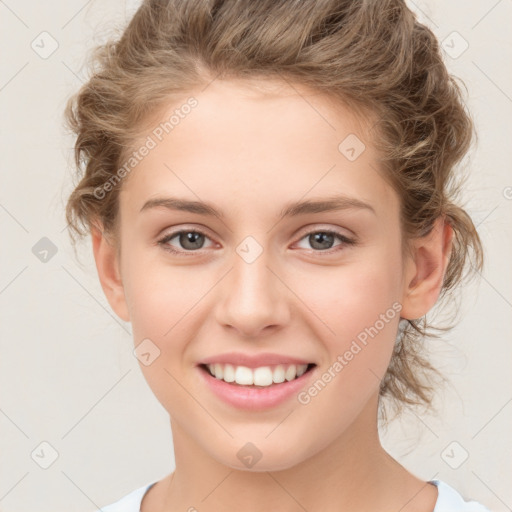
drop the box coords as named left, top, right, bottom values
left=207, top=363, right=308, bottom=386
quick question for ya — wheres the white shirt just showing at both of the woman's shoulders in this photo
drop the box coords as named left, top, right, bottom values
left=95, top=480, right=490, bottom=512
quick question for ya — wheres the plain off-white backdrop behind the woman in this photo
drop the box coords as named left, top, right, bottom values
left=0, top=0, right=512, bottom=512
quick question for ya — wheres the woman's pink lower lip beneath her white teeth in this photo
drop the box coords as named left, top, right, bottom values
left=198, top=366, right=316, bottom=411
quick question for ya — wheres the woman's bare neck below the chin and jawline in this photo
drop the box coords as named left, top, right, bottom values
left=141, top=397, right=437, bottom=512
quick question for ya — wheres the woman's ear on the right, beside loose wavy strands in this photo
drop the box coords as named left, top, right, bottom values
left=400, top=217, right=453, bottom=320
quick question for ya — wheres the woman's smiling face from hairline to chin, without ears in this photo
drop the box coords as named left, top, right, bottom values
left=107, top=80, right=412, bottom=471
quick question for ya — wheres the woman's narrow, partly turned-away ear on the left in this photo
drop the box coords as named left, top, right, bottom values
left=91, top=224, right=130, bottom=322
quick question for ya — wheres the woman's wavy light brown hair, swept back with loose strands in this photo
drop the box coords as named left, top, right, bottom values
left=65, top=0, right=483, bottom=412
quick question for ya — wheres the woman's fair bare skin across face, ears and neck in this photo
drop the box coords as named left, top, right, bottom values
left=92, top=80, right=452, bottom=512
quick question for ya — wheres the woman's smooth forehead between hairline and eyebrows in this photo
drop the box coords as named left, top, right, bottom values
left=122, top=80, right=396, bottom=222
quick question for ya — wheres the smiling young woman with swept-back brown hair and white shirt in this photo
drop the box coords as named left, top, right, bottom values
left=67, top=0, right=487, bottom=512
